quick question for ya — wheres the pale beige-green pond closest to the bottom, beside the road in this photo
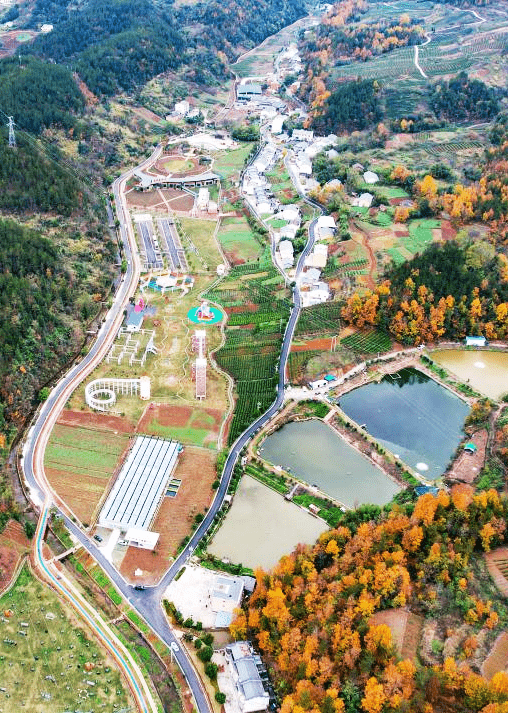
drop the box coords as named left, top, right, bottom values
left=208, top=475, right=328, bottom=569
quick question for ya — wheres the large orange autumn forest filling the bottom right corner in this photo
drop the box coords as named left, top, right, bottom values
left=231, top=486, right=508, bottom=713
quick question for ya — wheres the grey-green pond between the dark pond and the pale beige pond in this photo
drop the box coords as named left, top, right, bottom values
left=260, top=419, right=400, bottom=508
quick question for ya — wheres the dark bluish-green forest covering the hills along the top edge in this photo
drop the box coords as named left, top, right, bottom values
left=22, top=0, right=305, bottom=96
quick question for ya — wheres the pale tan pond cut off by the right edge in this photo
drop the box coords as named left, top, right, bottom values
left=430, top=349, right=508, bottom=401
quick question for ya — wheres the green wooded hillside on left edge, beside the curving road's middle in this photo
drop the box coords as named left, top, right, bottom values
left=0, top=219, right=115, bottom=445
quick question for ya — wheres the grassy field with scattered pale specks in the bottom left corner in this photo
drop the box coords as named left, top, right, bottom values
left=0, top=567, right=132, bottom=713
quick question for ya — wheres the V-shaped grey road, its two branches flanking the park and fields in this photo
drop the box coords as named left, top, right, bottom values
left=21, top=136, right=317, bottom=713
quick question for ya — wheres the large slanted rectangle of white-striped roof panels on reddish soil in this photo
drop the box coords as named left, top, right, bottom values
left=99, top=436, right=181, bottom=530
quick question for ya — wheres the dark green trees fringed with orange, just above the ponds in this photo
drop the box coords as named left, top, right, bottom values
left=342, top=241, right=508, bottom=344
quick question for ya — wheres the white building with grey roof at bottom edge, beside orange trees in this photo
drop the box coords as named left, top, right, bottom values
left=226, top=641, right=270, bottom=713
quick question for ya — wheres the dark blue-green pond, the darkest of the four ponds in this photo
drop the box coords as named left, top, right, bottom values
left=339, top=369, right=469, bottom=480
